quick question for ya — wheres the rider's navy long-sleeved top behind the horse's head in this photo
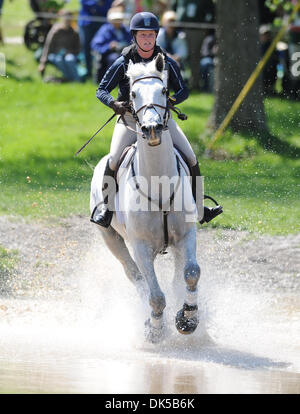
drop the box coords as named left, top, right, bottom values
left=97, top=45, right=189, bottom=106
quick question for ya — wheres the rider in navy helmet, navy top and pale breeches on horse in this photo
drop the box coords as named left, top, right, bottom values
left=91, top=12, right=222, bottom=227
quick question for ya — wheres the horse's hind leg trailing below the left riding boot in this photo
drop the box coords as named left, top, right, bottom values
left=98, top=226, right=146, bottom=295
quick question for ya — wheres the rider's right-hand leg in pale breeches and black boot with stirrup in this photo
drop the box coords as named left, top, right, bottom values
left=168, top=118, right=223, bottom=224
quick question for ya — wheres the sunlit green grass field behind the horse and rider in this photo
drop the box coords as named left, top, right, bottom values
left=0, top=40, right=300, bottom=234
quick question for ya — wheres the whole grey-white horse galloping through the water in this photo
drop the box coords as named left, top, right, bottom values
left=90, top=54, right=200, bottom=342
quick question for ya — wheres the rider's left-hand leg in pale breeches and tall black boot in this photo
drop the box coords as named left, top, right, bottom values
left=91, top=115, right=136, bottom=227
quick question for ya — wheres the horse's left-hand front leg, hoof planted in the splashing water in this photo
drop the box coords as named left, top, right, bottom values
left=133, top=240, right=166, bottom=343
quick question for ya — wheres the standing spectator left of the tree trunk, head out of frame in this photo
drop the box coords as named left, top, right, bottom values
left=174, top=0, right=215, bottom=90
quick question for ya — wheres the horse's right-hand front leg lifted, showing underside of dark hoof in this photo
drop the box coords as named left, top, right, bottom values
left=176, top=228, right=200, bottom=335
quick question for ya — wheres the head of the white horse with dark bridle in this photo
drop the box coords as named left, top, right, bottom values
left=127, top=53, right=169, bottom=146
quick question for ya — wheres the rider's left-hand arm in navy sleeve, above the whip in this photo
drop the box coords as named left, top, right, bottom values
left=96, top=56, right=125, bottom=107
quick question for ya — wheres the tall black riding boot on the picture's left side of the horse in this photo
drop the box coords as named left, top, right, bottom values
left=90, top=161, right=117, bottom=228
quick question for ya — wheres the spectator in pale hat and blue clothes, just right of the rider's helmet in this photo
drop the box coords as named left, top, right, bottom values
left=156, top=10, right=188, bottom=70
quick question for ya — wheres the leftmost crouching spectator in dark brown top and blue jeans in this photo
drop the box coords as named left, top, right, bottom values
left=39, top=10, right=81, bottom=82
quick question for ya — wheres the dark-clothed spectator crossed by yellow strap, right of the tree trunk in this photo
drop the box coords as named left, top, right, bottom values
left=259, top=24, right=279, bottom=95
